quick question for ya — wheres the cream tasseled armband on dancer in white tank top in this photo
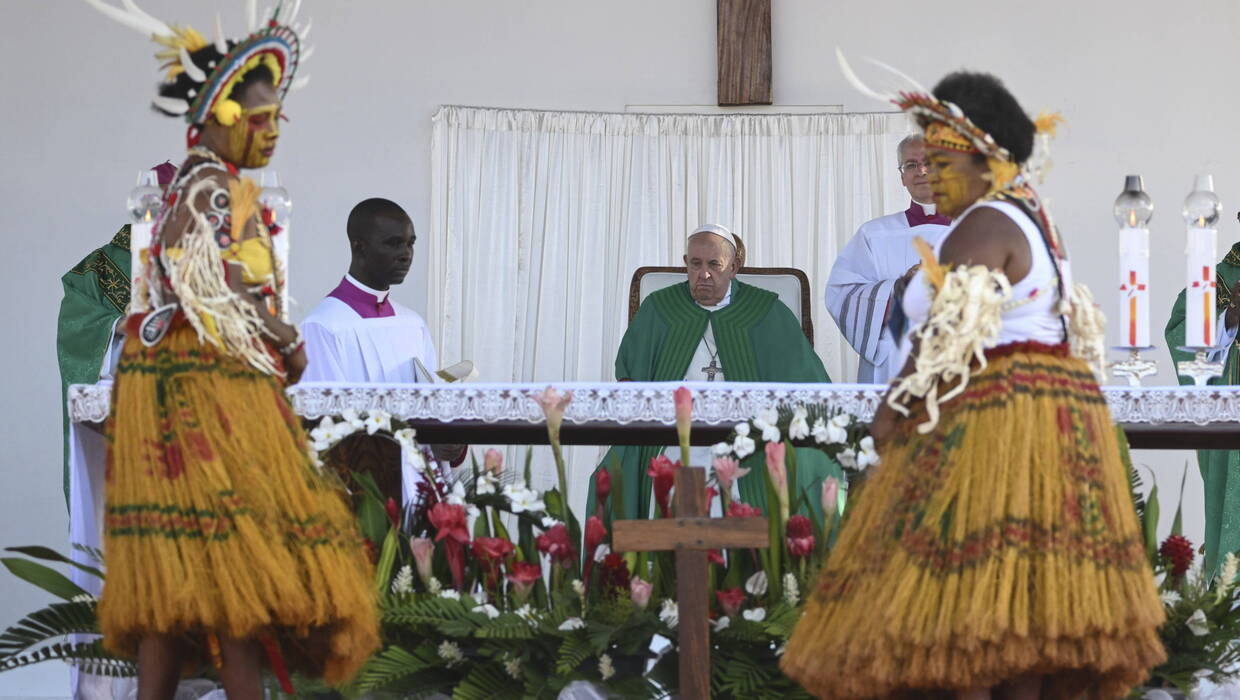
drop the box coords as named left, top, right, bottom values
left=887, top=253, right=1012, bottom=434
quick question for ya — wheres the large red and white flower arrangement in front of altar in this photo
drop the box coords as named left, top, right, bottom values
left=334, top=389, right=867, bottom=698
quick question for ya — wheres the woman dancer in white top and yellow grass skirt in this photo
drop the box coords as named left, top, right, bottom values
left=781, top=65, right=1164, bottom=699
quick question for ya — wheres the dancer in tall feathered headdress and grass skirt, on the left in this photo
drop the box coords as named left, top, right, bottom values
left=92, top=1, right=378, bottom=700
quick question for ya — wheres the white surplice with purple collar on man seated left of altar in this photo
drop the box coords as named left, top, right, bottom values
left=301, top=275, right=439, bottom=507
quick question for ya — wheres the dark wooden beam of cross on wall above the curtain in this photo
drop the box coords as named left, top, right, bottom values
left=717, top=0, right=771, bottom=107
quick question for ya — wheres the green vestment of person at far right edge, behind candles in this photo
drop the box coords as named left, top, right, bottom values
left=1166, top=243, right=1240, bottom=575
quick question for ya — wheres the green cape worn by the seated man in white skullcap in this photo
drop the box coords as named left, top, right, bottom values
left=587, top=280, right=843, bottom=519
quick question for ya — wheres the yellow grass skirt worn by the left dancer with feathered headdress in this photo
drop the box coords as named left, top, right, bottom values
left=99, top=318, right=379, bottom=683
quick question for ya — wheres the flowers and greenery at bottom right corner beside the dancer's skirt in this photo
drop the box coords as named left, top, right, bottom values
left=1132, top=466, right=1240, bottom=695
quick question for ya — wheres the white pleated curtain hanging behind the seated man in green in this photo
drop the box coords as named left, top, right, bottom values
left=424, top=107, right=909, bottom=502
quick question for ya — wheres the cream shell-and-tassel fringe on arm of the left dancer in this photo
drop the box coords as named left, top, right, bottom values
left=161, top=180, right=284, bottom=377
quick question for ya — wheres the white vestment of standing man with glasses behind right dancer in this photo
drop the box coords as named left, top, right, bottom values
left=826, top=202, right=951, bottom=384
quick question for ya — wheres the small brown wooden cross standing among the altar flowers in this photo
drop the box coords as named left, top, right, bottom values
left=611, top=467, right=769, bottom=700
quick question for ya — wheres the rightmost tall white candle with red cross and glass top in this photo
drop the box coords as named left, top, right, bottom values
left=1184, top=175, right=1223, bottom=348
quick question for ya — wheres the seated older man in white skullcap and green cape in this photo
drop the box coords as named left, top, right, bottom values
left=587, top=224, right=843, bottom=519
